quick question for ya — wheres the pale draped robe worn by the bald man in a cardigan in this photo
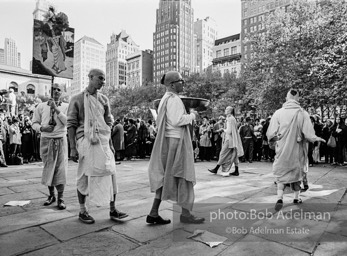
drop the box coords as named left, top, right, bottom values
left=77, top=91, right=117, bottom=205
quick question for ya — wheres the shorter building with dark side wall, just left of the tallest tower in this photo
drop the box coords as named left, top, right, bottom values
left=126, top=50, right=153, bottom=87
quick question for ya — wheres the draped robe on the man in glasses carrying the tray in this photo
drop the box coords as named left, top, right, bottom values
left=148, top=93, right=196, bottom=210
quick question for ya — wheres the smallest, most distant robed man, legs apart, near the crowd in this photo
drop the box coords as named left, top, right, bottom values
left=209, top=106, right=244, bottom=177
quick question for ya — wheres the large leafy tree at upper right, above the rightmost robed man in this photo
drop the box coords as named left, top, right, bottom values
left=243, top=0, right=346, bottom=117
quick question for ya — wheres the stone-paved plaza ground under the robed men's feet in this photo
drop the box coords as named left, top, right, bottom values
left=0, top=160, right=347, bottom=256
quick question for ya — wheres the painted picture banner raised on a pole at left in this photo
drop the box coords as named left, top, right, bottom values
left=32, top=7, right=75, bottom=79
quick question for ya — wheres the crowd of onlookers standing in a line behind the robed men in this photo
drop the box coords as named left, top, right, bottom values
left=0, top=100, right=347, bottom=170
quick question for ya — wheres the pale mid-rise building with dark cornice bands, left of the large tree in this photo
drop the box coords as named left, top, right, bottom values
left=212, top=34, right=241, bottom=76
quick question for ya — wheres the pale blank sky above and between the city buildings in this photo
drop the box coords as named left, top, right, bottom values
left=0, top=0, right=241, bottom=69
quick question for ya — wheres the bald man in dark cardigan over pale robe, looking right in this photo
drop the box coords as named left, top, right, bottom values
left=67, top=69, right=128, bottom=224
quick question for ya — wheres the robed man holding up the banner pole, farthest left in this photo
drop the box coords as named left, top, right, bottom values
left=32, top=84, right=68, bottom=210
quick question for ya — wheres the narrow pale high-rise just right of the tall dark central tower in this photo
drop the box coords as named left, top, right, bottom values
left=194, top=17, right=217, bottom=73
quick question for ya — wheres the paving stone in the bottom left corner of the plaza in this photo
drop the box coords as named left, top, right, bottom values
left=0, top=227, right=59, bottom=256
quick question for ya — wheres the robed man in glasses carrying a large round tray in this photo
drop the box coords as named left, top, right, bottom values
left=146, top=71, right=205, bottom=225
